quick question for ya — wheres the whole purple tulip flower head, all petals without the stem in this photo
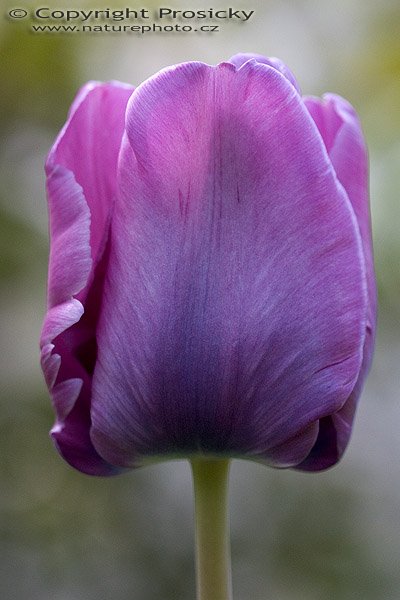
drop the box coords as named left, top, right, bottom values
left=41, top=55, right=376, bottom=475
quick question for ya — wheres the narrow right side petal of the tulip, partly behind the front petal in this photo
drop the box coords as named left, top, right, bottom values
left=300, top=94, right=376, bottom=470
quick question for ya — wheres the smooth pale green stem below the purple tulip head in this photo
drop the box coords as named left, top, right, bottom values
left=191, top=458, right=232, bottom=600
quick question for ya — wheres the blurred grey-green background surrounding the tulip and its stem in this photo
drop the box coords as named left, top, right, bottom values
left=0, top=0, right=400, bottom=600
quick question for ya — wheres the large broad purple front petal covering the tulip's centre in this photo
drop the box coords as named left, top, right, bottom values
left=92, top=61, right=366, bottom=466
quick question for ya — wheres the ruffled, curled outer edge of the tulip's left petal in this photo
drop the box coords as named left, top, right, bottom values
left=40, top=165, right=122, bottom=475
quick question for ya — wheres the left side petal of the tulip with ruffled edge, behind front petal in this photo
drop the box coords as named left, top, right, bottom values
left=41, top=83, right=132, bottom=475
